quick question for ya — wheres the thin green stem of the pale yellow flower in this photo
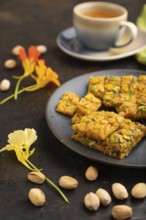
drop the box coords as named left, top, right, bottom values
left=26, top=160, right=69, bottom=203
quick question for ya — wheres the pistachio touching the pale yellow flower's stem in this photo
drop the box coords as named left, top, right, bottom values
left=27, top=171, right=45, bottom=184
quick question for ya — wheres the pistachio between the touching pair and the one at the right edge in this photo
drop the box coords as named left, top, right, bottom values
left=112, top=183, right=128, bottom=200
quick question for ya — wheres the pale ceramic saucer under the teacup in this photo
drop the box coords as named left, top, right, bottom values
left=57, top=27, right=146, bottom=61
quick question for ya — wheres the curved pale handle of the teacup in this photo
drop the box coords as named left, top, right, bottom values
left=113, top=21, right=138, bottom=48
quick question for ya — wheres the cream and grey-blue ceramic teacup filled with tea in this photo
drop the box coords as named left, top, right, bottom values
left=73, top=2, right=137, bottom=50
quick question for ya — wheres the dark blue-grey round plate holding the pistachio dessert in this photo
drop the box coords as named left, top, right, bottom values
left=46, top=69, right=146, bottom=168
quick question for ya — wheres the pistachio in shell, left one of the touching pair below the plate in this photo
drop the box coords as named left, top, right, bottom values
left=84, top=192, right=100, bottom=211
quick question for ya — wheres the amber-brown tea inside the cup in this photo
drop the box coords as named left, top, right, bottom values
left=83, top=10, right=119, bottom=18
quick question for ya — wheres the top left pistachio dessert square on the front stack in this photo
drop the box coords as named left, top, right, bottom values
left=72, top=111, right=124, bottom=140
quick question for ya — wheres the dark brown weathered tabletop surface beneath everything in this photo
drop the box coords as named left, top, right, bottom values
left=0, top=0, right=146, bottom=220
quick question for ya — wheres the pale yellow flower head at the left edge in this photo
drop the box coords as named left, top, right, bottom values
left=0, top=128, right=37, bottom=170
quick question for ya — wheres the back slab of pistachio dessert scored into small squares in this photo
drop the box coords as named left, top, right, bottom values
left=88, top=75, right=146, bottom=120
